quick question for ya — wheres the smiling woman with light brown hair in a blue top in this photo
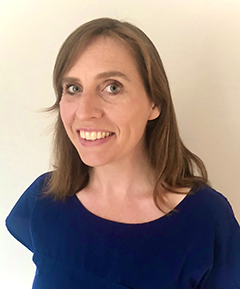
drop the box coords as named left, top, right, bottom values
left=7, top=18, right=240, bottom=289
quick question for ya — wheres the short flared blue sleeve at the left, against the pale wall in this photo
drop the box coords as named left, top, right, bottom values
left=6, top=174, right=47, bottom=252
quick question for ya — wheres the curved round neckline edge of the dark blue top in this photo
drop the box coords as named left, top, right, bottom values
left=73, top=190, right=195, bottom=227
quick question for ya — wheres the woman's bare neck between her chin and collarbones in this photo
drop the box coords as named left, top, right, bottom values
left=88, top=150, right=155, bottom=200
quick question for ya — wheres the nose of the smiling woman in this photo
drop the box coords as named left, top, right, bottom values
left=76, top=92, right=103, bottom=120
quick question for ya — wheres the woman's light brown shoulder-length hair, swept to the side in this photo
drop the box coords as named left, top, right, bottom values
left=44, top=18, right=208, bottom=209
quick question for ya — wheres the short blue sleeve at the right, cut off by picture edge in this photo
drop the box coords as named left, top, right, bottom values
left=198, top=197, right=240, bottom=289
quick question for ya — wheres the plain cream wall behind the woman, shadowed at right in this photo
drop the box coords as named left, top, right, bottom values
left=0, top=0, right=240, bottom=289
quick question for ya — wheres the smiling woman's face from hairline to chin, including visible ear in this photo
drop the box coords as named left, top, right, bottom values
left=60, top=37, right=159, bottom=167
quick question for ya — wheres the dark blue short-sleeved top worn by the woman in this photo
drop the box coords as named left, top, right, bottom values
left=6, top=174, right=240, bottom=289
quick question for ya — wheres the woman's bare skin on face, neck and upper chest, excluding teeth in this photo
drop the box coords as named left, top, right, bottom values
left=60, top=37, right=186, bottom=223
